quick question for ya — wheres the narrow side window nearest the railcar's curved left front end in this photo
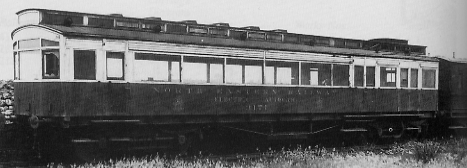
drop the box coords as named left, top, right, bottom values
left=42, top=50, right=60, bottom=79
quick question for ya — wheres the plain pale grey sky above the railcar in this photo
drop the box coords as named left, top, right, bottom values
left=0, top=0, right=467, bottom=80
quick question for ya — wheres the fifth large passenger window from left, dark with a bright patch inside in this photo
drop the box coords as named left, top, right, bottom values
left=301, top=63, right=331, bottom=86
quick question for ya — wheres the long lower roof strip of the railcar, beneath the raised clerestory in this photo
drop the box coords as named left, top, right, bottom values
left=11, top=24, right=437, bottom=61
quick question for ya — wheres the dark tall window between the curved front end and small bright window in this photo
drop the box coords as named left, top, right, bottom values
left=73, top=50, right=96, bottom=80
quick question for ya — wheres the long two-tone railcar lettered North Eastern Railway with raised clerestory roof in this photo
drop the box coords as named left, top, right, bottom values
left=1, top=9, right=439, bottom=162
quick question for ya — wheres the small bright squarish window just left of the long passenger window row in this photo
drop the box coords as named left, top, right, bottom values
left=106, top=52, right=125, bottom=80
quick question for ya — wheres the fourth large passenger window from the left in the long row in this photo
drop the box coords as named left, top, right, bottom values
left=264, top=61, right=298, bottom=85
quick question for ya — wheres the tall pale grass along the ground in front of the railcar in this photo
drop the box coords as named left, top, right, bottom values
left=50, top=139, right=467, bottom=168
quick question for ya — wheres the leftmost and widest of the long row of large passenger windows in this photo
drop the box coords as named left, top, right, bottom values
left=134, top=53, right=180, bottom=82
